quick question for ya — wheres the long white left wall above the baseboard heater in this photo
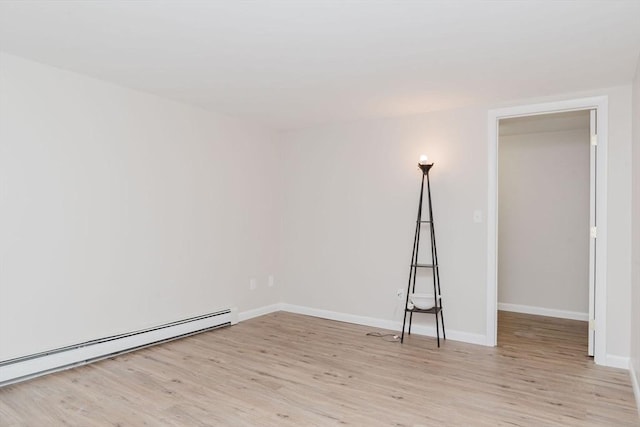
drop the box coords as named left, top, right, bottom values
left=0, top=54, right=280, bottom=360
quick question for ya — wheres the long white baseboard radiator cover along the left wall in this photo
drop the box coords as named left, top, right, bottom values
left=0, top=309, right=237, bottom=387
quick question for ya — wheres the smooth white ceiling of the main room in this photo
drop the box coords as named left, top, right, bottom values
left=0, top=0, right=640, bottom=129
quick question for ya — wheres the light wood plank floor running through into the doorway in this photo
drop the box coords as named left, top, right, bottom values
left=0, top=313, right=640, bottom=426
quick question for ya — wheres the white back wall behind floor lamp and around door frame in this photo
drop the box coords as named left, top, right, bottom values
left=282, top=86, right=631, bottom=357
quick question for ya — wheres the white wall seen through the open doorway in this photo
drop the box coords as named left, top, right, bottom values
left=498, top=125, right=590, bottom=317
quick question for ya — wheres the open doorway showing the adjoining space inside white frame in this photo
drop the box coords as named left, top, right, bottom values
left=498, top=110, right=595, bottom=356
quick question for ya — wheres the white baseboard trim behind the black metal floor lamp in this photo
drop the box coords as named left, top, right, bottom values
left=280, top=304, right=486, bottom=346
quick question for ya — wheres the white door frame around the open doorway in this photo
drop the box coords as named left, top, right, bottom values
left=485, top=96, right=609, bottom=365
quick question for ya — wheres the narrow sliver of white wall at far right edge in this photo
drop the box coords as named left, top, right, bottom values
left=631, top=55, right=640, bottom=400
